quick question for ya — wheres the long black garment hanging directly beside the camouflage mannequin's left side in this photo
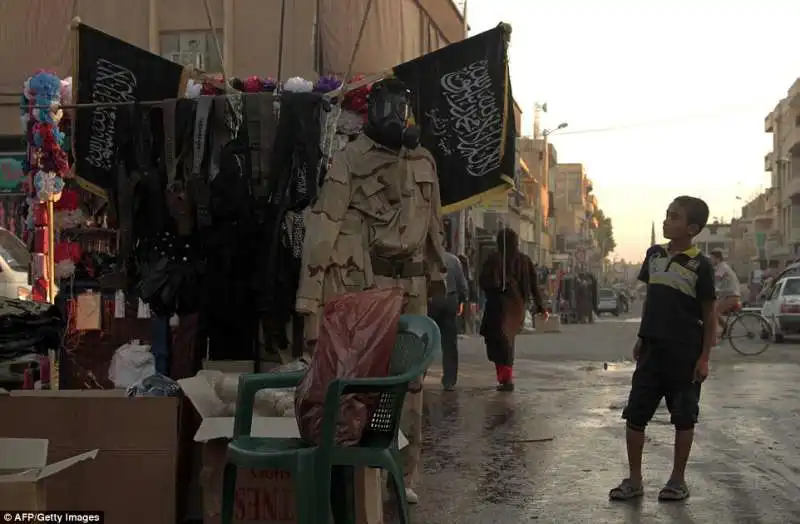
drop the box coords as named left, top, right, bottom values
left=255, top=93, right=330, bottom=348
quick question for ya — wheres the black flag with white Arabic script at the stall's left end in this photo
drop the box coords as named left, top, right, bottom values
left=73, top=24, right=184, bottom=199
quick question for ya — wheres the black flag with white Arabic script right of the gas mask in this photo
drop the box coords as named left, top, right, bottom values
left=394, top=25, right=517, bottom=212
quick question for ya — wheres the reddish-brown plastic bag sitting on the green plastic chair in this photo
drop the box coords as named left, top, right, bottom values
left=295, top=288, right=403, bottom=446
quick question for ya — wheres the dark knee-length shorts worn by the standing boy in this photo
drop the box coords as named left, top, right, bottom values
left=622, top=339, right=701, bottom=431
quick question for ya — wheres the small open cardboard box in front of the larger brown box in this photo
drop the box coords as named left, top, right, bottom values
left=0, top=438, right=98, bottom=511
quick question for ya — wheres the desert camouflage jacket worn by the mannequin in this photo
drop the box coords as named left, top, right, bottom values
left=296, top=135, right=446, bottom=339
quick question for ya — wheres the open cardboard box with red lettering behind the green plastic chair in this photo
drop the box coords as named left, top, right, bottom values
left=178, top=371, right=408, bottom=524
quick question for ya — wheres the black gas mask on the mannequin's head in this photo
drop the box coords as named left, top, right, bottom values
left=364, top=78, right=420, bottom=150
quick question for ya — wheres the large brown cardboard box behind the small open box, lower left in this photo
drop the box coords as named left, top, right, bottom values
left=0, top=390, right=181, bottom=524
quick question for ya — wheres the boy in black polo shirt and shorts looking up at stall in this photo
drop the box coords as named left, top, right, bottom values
left=609, top=196, right=717, bottom=501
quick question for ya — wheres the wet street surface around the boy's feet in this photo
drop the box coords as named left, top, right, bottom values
left=412, top=310, right=800, bottom=524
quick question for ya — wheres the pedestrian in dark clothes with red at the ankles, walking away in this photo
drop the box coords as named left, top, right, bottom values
left=478, top=228, right=548, bottom=391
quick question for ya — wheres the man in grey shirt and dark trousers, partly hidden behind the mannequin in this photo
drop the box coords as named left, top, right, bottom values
left=428, top=252, right=469, bottom=391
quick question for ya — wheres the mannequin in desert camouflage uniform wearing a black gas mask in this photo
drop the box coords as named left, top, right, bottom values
left=296, top=79, right=446, bottom=502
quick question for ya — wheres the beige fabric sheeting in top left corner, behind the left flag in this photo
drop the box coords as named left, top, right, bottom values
left=0, top=0, right=149, bottom=134
